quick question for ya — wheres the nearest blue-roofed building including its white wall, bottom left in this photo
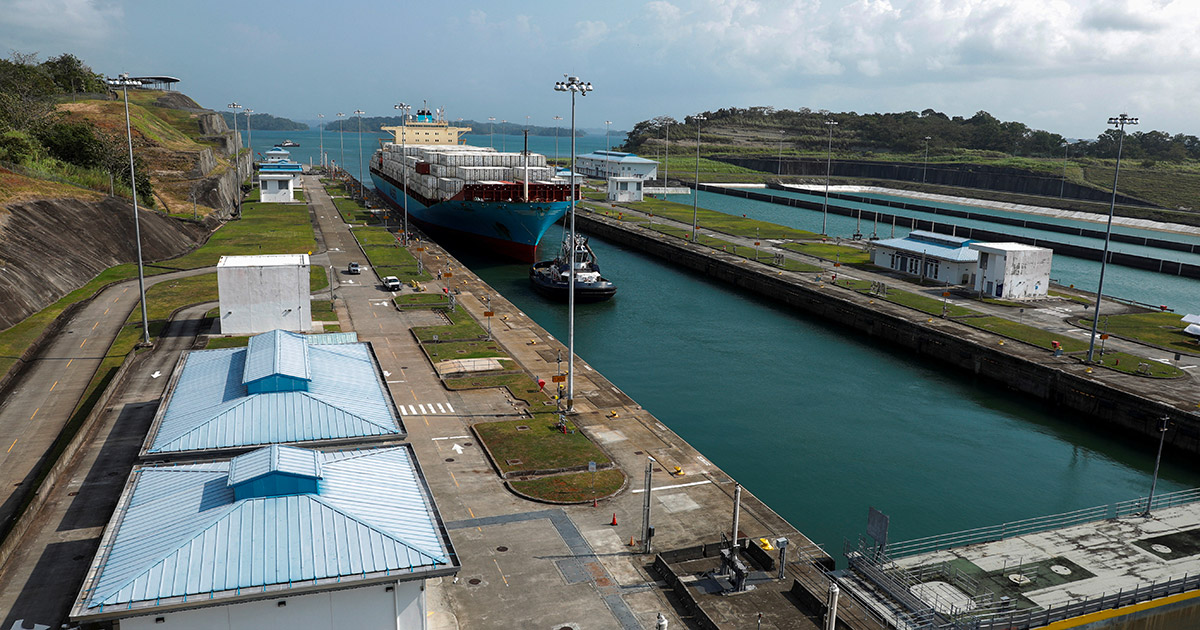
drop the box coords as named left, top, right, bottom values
left=71, top=445, right=460, bottom=630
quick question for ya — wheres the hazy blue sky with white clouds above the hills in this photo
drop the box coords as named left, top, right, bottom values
left=0, top=0, right=1200, bottom=138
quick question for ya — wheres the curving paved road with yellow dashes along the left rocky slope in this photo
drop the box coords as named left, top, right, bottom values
left=0, top=269, right=214, bottom=532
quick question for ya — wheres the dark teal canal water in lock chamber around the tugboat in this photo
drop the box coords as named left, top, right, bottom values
left=450, top=229, right=1200, bottom=558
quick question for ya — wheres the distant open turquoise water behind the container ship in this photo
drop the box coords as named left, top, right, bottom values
left=247, top=127, right=619, bottom=187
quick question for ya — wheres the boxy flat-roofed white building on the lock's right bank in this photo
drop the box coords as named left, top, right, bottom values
left=971, top=242, right=1054, bottom=300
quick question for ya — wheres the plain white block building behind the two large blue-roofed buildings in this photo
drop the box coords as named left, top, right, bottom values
left=217, top=253, right=312, bottom=335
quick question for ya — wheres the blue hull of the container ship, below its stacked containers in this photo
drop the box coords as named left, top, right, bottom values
left=371, top=168, right=570, bottom=262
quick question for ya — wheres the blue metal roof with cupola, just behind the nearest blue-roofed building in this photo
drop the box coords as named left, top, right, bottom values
left=142, top=330, right=406, bottom=458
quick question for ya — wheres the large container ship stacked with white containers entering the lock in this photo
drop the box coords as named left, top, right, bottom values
left=370, top=109, right=571, bottom=262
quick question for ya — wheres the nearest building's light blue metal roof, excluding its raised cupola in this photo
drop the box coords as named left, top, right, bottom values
left=77, top=446, right=456, bottom=612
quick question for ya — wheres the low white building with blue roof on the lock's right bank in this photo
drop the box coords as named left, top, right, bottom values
left=871, top=229, right=979, bottom=284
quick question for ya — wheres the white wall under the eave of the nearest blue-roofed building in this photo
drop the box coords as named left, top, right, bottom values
left=120, top=581, right=425, bottom=630
